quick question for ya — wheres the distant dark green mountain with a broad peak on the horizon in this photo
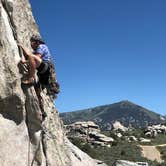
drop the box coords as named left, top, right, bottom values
left=60, top=100, right=166, bottom=129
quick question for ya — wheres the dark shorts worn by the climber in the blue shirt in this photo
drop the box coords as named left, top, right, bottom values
left=37, top=62, right=50, bottom=85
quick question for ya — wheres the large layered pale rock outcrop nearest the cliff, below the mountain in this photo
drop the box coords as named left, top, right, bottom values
left=66, top=121, right=114, bottom=147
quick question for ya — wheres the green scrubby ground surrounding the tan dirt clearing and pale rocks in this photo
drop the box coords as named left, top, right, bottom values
left=69, top=129, right=166, bottom=166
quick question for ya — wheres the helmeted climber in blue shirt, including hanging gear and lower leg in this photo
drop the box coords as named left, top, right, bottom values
left=19, top=35, right=59, bottom=117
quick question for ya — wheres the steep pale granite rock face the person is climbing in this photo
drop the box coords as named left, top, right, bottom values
left=0, top=0, right=106, bottom=166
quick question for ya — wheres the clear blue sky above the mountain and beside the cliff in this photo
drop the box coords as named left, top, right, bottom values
left=30, top=0, right=166, bottom=114
